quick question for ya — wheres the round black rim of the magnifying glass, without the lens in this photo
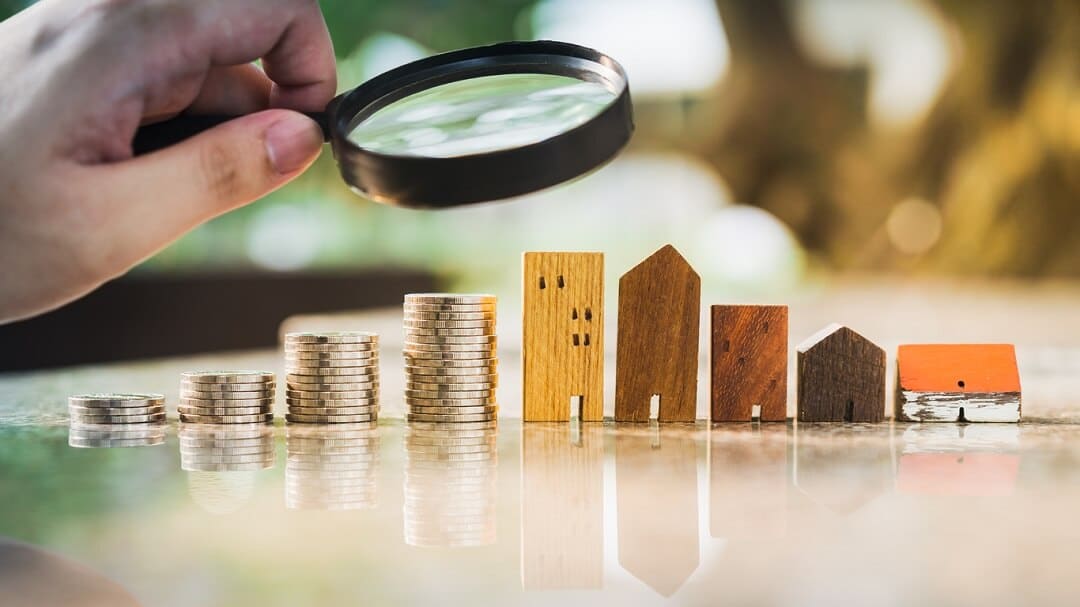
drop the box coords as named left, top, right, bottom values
left=328, top=40, right=634, bottom=208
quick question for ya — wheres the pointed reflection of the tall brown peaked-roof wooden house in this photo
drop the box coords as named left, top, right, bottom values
left=615, top=426, right=700, bottom=596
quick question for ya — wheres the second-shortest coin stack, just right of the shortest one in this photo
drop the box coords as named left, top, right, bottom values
left=177, top=370, right=275, bottom=423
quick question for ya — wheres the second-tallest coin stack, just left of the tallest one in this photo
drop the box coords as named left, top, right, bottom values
left=285, top=331, right=379, bottom=423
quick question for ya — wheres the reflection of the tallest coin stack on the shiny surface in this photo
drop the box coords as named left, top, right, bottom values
left=405, top=422, right=498, bottom=547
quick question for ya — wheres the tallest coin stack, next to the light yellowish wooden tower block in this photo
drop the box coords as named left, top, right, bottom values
left=404, top=293, right=499, bottom=424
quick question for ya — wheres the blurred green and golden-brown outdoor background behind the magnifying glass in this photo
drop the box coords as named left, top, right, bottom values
left=0, top=0, right=1080, bottom=293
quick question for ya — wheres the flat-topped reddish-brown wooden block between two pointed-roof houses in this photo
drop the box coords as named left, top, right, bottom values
left=711, top=306, right=787, bottom=422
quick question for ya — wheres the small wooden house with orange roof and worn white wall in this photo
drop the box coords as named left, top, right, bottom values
left=895, top=343, right=1021, bottom=421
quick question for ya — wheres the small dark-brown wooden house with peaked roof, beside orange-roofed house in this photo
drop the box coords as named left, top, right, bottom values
left=798, top=325, right=885, bottom=423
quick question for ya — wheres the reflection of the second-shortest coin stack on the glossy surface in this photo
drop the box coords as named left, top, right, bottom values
left=179, top=424, right=274, bottom=472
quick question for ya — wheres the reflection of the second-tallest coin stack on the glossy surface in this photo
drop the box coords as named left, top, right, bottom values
left=285, top=423, right=379, bottom=510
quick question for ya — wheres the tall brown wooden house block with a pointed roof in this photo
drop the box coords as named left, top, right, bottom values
left=615, top=245, right=701, bottom=421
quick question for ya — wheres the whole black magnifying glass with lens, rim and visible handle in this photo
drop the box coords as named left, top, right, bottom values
left=133, top=41, right=634, bottom=208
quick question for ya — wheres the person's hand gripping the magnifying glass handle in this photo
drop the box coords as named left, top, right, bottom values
left=0, top=0, right=337, bottom=322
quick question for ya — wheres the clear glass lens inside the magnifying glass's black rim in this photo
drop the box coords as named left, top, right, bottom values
left=349, top=73, right=618, bottom=158
